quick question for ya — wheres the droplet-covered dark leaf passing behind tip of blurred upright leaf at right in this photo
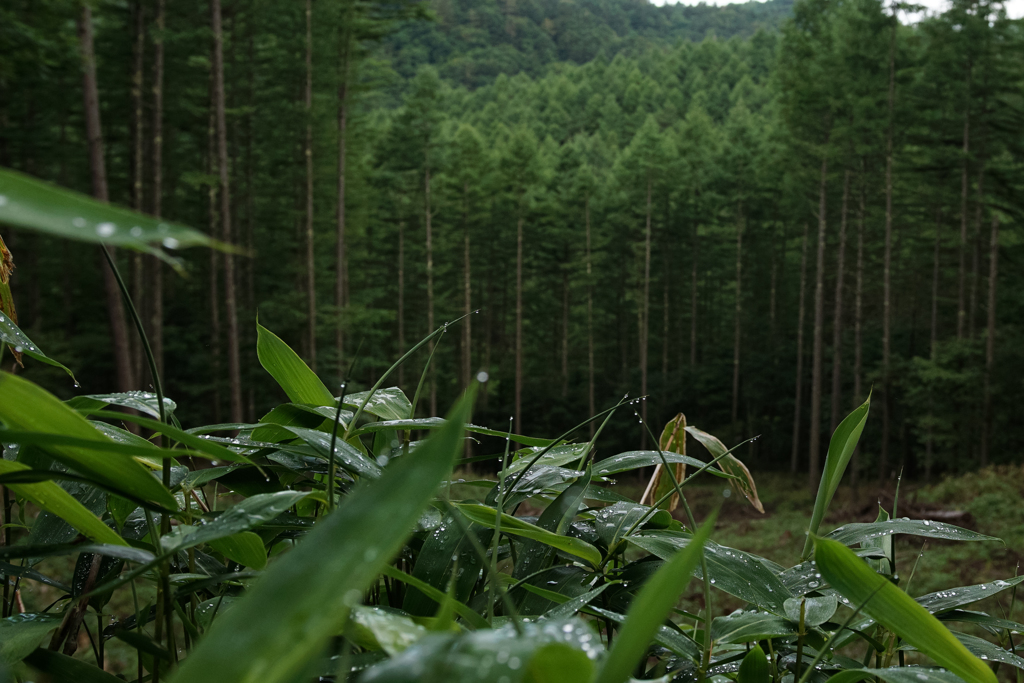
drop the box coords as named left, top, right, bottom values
left=626, top=529, right=793, bottom=614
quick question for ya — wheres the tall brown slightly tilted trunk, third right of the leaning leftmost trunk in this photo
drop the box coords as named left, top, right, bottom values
left=210, top=0, right=242, bottom=422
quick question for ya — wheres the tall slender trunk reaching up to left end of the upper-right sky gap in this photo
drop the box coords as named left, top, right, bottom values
left=879, top=18, right=896, bottom=481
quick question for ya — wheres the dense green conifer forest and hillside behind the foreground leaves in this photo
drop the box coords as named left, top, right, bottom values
left=0, top=0, right=1024, bottom=480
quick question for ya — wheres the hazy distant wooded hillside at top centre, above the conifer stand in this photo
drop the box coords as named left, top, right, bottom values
left=381, top=0, right=794, bottom=87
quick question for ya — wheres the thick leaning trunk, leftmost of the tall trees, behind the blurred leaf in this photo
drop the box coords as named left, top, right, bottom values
left=78, top=2, right=136, bottom=391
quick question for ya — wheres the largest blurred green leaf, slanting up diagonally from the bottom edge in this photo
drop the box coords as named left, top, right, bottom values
left=165, top=390, right=475, bottom=683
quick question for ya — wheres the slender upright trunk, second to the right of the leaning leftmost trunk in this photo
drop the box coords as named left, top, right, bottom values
left=150, top=0, right=167, bottom=375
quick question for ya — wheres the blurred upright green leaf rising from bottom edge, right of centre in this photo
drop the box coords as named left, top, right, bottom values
left=596, top=507, right=716, bottom=683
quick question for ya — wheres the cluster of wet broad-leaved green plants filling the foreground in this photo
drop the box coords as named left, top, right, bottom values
left=0, top=172, right=1024, bottom=683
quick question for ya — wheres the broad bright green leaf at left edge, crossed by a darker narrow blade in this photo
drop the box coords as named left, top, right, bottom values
left=0, top=373, right=177, bottom=509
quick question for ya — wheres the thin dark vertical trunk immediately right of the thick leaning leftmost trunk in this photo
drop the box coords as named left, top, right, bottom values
left=129, top=0, right=147, bottom=383
